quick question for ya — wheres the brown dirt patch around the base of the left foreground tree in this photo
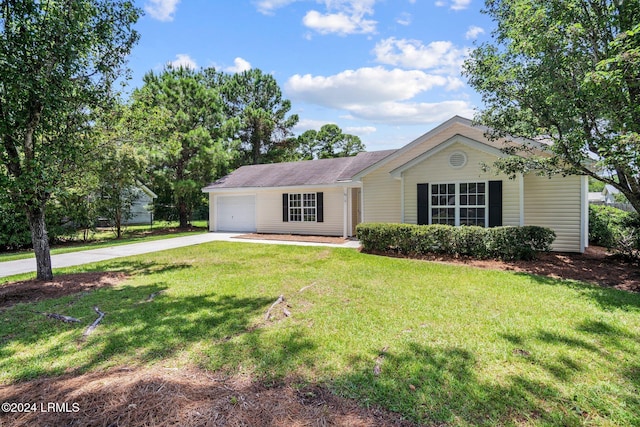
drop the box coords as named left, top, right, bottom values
left=0, top=272, right=126, bottom=309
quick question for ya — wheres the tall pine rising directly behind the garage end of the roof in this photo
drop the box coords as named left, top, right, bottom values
left=222, top=68, right=298, bottom=164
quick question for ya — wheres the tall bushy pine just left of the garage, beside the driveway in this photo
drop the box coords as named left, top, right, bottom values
left=132, top=66, right=232, bottom=228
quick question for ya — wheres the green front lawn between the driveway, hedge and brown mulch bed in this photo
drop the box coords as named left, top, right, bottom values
left=0, top=242, right=640, bottom=425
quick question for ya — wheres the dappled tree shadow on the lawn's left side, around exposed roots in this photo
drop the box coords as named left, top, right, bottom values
left=0, top=282, right=272, bottom=380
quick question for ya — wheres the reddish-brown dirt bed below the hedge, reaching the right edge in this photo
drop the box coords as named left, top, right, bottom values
left=376, top=246, right=640, bottom=292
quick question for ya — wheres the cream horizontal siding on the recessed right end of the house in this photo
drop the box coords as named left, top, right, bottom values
left=524, top=175, right=583, bottom=252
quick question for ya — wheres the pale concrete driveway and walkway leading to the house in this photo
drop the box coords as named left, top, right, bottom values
left=0, top=233, right=360, bottom=277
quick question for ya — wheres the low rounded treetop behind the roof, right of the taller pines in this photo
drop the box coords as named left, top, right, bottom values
left=297, top=124, right=365, bottom=160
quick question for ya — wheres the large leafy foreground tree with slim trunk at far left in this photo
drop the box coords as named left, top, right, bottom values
left=0, top=0, right=140, bottom=280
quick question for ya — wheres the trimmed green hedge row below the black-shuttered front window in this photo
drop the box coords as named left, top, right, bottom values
left=356, top=223, right=556, bottom=260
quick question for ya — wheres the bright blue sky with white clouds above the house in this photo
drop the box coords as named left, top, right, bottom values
left=129, top=0, right=493, bottom=151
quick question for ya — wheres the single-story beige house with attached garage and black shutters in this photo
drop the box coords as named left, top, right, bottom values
left=203, top=116, right=588, bottom=252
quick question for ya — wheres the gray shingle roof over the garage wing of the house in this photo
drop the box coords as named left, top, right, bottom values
left=203, top=150, right=396, bottom=190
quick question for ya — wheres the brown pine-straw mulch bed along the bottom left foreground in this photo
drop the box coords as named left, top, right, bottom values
left=0, top=367, right=413, bottom=427
